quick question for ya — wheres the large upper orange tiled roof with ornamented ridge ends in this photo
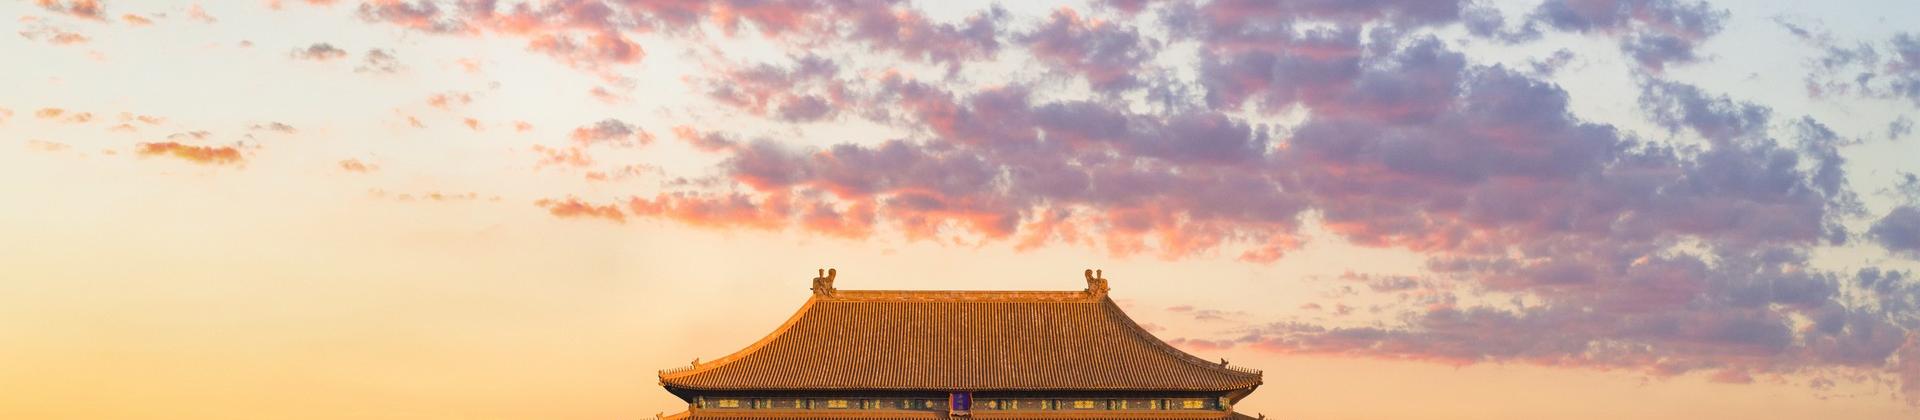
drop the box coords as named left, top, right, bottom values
left=660, top=278, right=1260, bottom=391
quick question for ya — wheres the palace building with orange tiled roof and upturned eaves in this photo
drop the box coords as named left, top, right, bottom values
left=660, top=270, right=1261, bottom=418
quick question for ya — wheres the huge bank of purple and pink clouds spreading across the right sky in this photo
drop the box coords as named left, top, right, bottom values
left=288, top=0, right=1920, bottom=406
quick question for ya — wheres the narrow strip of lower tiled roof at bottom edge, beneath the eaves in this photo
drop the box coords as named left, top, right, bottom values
left=666, top=410, right=1252, bottom=420
